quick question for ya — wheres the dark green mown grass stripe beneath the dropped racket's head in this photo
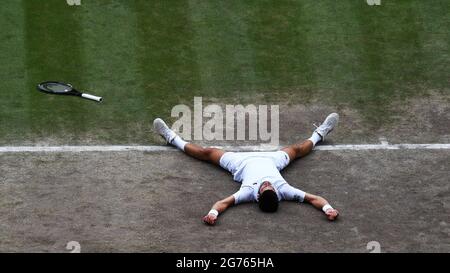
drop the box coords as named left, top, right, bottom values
left=22, top=0, right=89, bottom=142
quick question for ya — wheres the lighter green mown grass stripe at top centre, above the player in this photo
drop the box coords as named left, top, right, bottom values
left=188, top=0, right=259, bottom=99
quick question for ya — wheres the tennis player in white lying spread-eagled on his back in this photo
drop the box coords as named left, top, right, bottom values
left=153, top=113, right=339, bottom=225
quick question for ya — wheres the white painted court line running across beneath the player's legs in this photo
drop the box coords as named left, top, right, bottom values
left=0, top=143, right=450, bottom=153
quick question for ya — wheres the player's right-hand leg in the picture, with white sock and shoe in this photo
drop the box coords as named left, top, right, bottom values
left=282, top=113, right=339, bottom=161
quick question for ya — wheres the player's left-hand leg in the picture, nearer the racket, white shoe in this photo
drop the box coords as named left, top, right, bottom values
left=153, top=118, right=225, bottom=165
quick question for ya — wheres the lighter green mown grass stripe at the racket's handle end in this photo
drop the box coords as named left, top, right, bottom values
left=80, top=0, right=146, bottom=143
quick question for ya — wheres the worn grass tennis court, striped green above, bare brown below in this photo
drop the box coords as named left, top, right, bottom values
left=0, top=0, right=450, bottom=253
